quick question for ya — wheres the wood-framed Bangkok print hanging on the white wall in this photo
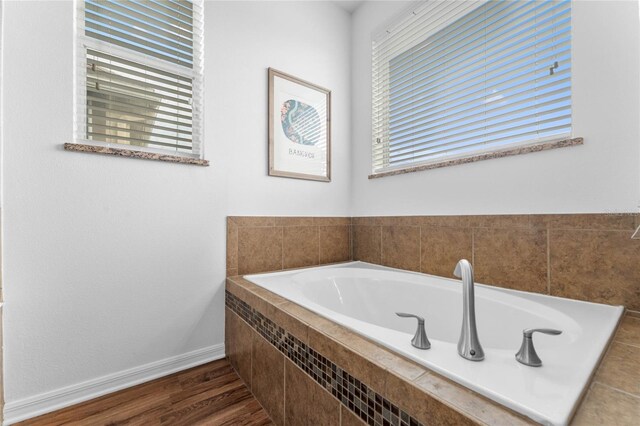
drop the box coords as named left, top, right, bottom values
left=269, top=68, right=331, bottom=182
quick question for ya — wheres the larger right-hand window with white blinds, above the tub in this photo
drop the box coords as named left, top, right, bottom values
left=372, top=0, right=571, bottom=175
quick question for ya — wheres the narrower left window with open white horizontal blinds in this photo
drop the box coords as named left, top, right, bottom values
left=76, top=0, right=203, bottom=158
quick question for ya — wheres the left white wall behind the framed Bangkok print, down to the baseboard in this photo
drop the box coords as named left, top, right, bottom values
left=2, top=1, right=350, bottom=420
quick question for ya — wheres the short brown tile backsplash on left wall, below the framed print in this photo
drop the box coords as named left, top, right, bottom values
left=227, top=216, right=352, bottom=276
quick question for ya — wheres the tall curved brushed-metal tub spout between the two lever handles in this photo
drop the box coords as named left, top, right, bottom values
left=453, top=259, right=484, bottom=361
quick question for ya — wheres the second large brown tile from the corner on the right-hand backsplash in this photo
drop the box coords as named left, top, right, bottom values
left=382, top=226, right=420, bottom=272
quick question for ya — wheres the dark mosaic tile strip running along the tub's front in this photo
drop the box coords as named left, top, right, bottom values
left=225, top=290, right=423, bottom=426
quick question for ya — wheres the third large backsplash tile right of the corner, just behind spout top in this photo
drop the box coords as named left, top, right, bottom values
left=420, top=227, right=473, bottom=278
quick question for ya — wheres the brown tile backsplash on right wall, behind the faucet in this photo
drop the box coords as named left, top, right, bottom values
left=352, top=213, right=640, bottom=311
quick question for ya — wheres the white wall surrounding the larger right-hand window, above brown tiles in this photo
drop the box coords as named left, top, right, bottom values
left=351, top=1, right=640, bottom=215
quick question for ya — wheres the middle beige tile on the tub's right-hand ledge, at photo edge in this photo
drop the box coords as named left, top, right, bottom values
left=595, top=342, right=640, bottom=397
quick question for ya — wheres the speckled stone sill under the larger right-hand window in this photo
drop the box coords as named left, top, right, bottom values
left=369, top=138, right=584, bottom=179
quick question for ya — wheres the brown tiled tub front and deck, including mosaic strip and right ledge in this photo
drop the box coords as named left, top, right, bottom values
left=225, top=277, right=640, bottom=426
